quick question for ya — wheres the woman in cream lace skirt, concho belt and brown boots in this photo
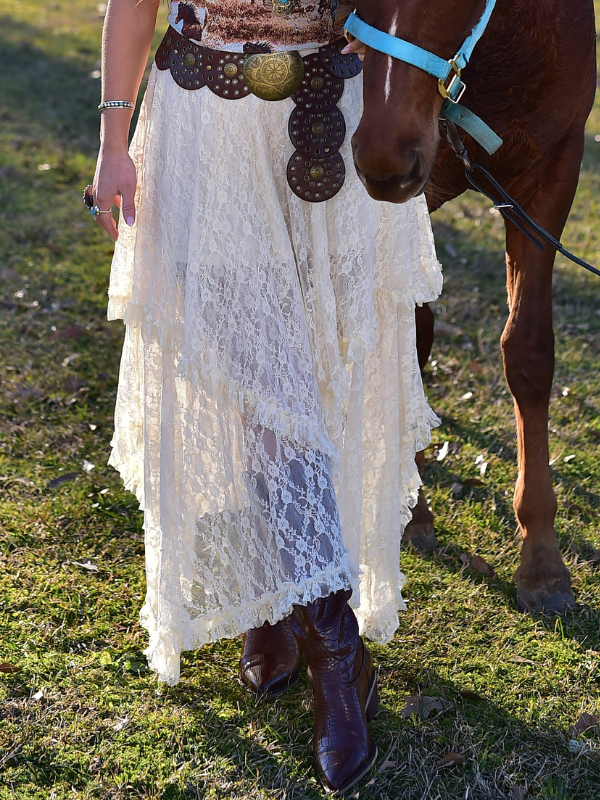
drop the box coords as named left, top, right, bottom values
left=86, top=0, right=441, bottom=791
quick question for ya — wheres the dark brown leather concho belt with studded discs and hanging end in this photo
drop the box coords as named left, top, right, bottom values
left=155, top=28, right=362, bottom=203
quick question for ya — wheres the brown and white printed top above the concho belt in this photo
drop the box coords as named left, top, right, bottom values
left=169, top=0, right=354, bottom=53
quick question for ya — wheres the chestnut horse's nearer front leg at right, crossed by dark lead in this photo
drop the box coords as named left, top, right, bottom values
left=501, top=139, right=581, bottom=613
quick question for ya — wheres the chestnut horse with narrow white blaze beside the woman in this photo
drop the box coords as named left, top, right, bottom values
left=352, top=0, right=596, bottom=613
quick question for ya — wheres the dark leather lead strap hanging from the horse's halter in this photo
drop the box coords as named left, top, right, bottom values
left=440, top=120, right=600, bottom=276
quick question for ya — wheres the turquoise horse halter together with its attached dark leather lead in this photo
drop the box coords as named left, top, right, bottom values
left=345, top=5, right=600, bottom=276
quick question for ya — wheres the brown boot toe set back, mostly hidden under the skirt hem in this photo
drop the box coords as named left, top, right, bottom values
left=240, top=619, right=300, bottom=696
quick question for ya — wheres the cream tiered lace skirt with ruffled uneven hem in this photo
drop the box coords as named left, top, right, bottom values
left=108, top=59, right=441, bottom=683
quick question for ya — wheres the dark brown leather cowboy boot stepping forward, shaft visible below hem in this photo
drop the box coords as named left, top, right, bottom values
left=290, top=591, right=377, bottom=793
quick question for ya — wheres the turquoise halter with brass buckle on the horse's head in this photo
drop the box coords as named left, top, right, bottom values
left=345, top=0, right=502, bottom=155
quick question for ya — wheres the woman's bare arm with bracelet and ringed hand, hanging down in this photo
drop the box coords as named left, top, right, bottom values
left=93, top=0, right=160, bottom=241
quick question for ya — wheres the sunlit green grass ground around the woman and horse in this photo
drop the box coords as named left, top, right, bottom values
left=0, top=0, right=600, bottom=800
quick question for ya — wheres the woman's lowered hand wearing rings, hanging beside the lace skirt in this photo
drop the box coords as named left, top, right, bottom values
left=92, top=147, right=136, bottom=242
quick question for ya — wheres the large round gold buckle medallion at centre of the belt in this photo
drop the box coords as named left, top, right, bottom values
left=242, top=50, right=304, bottom=100
